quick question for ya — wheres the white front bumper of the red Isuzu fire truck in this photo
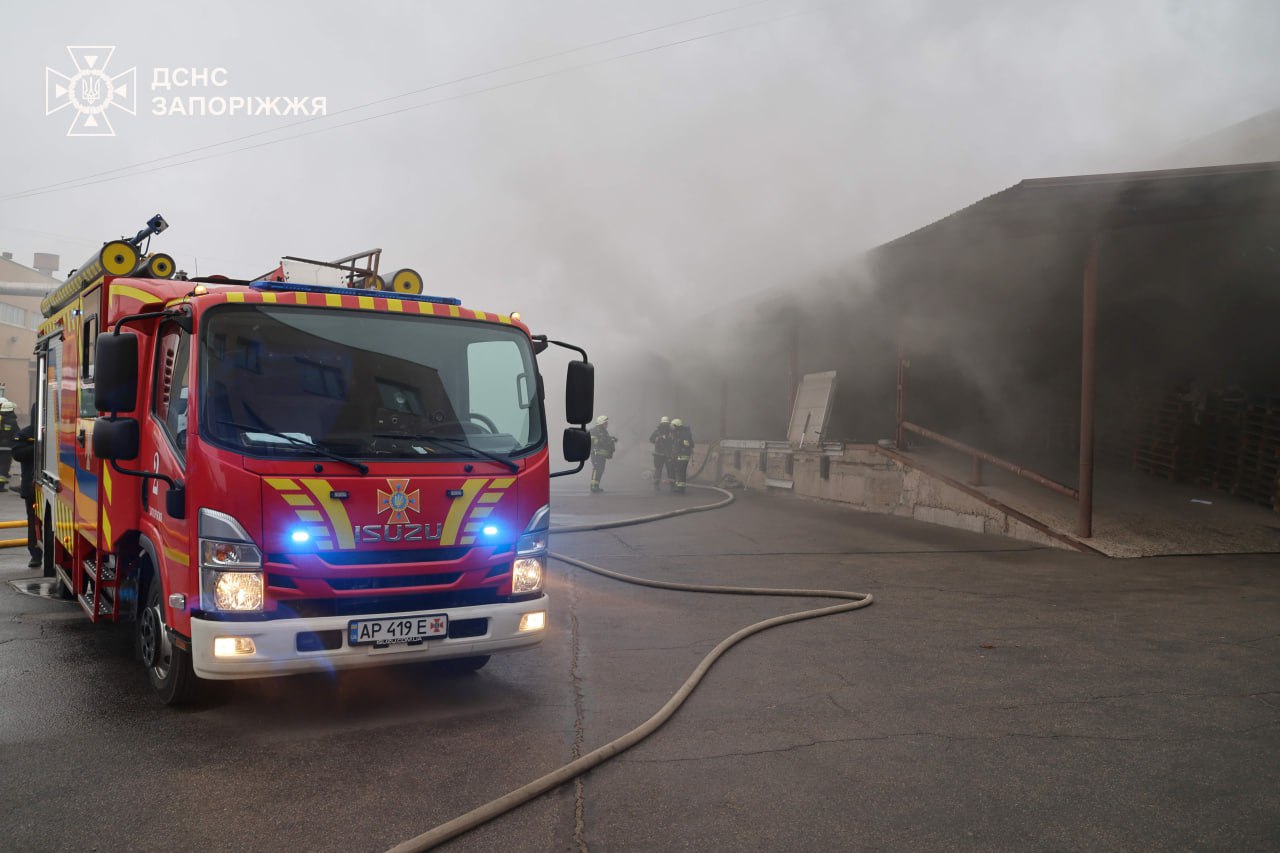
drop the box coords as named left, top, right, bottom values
left=191, top=596, right=549, bottom=680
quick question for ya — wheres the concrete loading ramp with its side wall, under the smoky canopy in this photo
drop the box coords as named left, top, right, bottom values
left=692, top=442, right=1280, bottom=557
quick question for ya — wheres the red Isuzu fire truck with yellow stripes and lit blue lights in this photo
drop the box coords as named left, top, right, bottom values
left=36, top=216, right=594, bottom=704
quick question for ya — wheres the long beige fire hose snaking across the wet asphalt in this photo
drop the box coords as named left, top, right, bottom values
left=388, top=481, right=874, bottom=853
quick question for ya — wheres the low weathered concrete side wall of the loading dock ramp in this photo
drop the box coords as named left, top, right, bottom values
left=690, top=444, right=1070, bottom=548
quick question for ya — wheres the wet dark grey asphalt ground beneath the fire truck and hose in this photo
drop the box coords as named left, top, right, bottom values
left=0, top=478, right=1280, bottom=852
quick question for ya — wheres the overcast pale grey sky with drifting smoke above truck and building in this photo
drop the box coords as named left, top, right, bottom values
left=0, top=0, right=1280, bottom=343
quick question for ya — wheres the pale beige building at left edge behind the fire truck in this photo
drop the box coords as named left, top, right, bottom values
left=0, top=252, right=61, bottom=424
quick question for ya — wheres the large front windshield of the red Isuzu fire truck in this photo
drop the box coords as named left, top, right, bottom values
left=197, top=298, right=544, bottom=461
